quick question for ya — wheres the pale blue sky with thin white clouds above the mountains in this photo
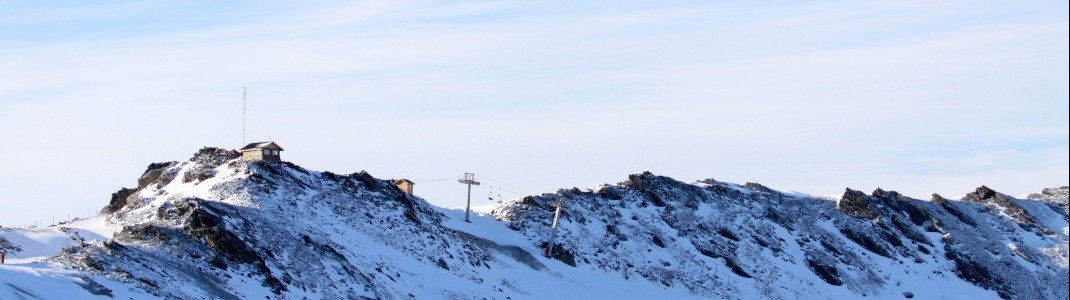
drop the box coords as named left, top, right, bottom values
left=0, top=1, right=1070, bottom=226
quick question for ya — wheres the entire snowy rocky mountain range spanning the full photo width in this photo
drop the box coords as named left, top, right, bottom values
left=0, top=148, right=1068, bottom=299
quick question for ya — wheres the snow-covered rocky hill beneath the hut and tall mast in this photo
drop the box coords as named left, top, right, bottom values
left=0, top=148, right=693, bottom=299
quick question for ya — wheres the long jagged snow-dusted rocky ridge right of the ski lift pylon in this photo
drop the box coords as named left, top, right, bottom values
left=492, top=173, right=1068, bottom=299
